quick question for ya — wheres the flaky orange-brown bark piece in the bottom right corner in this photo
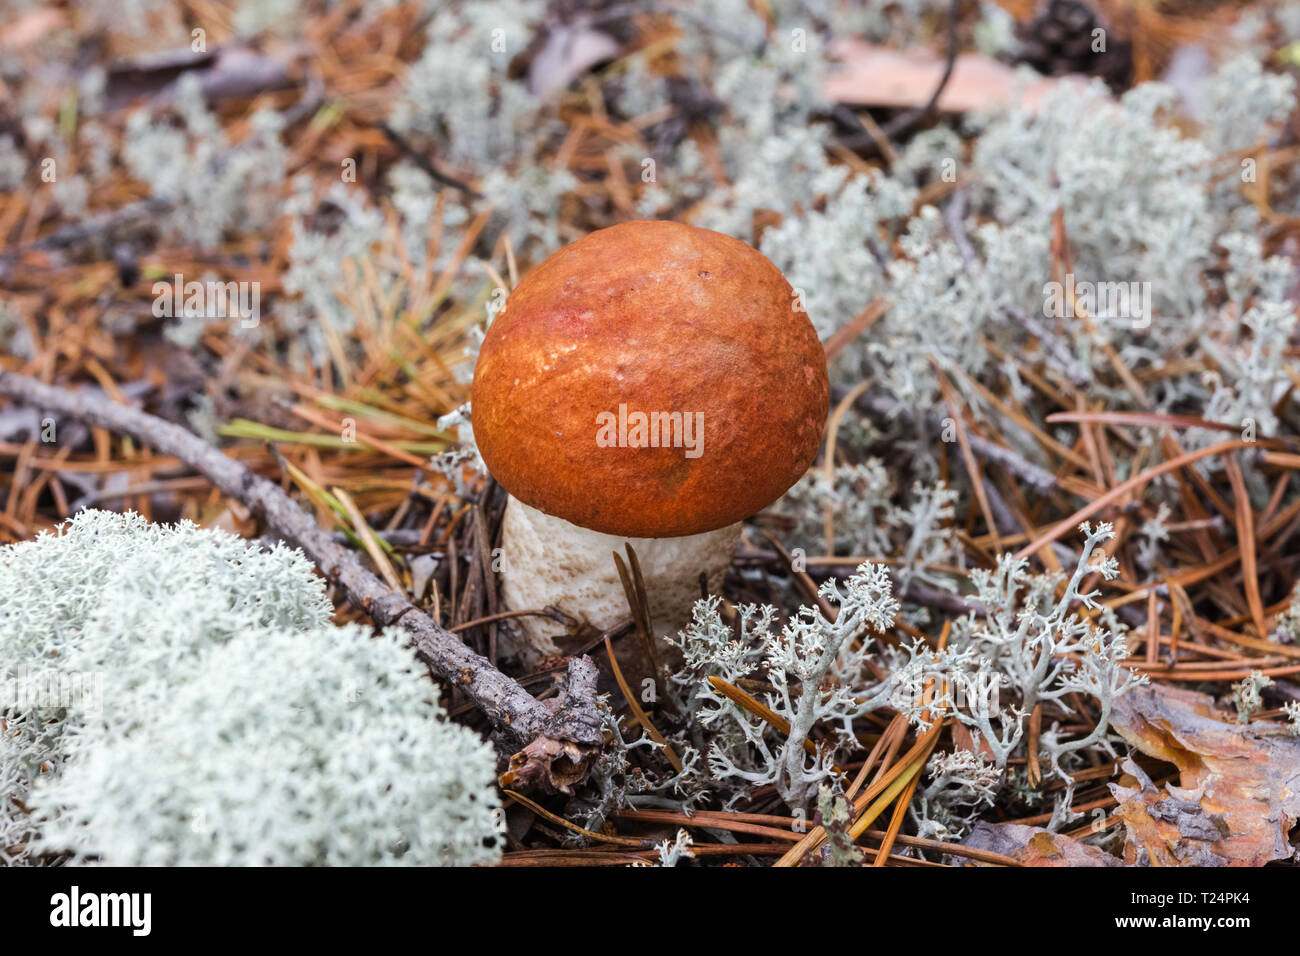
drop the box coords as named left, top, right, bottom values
left=1110, top=684, right=1300, bottom=866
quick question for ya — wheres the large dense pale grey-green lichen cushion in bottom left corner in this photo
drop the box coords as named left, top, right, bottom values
left=0, top=511, right=501, bottom=865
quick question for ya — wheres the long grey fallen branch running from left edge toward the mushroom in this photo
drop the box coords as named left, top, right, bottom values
left=0, top=371, right=602, bottom=791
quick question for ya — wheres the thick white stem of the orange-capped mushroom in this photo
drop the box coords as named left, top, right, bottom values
left=502, top=497, right=741, bottom=663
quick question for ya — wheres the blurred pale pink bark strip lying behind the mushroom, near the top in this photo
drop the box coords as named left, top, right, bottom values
left=824, top=39, right=1086, bottom=113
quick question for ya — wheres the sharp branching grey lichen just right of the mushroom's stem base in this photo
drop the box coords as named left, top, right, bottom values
left=650, top=524, right=1145, bottom=839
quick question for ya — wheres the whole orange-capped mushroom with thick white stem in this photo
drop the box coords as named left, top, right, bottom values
left=472, top=221, right=828, bottom=662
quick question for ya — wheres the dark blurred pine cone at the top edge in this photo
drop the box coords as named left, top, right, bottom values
left=1017, top=0, right=1132, bottom=90
